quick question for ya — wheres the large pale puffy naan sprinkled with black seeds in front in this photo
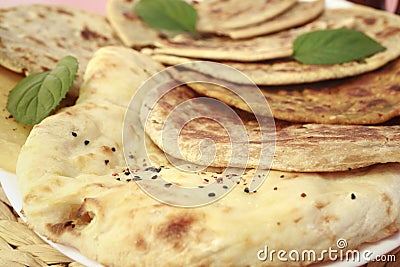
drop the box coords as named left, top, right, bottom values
left=17, top=48, right=400, bottom=266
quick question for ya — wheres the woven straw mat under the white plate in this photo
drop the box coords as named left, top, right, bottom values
left=0, top=187, right=400, bottom=267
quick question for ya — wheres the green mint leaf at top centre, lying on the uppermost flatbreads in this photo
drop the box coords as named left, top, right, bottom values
left=134, top=0, right=197, bottom=33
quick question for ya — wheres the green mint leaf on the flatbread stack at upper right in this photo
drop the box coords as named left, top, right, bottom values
left=293, top=29, right=386, bottom=65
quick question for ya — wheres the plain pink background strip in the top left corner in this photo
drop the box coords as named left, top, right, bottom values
left=0, top=0, right=107, bottom=15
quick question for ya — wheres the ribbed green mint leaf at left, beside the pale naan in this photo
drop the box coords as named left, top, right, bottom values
left=7, top=56, right=78, bottom=125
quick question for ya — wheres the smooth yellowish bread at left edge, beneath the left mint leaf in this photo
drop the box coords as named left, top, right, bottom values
left=0, top=67, right=31, bottom=173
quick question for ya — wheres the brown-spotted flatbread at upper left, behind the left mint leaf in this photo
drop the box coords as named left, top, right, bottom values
left=0, top=5, right=120, bottom=96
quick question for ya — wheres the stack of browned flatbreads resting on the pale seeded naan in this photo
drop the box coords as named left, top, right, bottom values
left=108, top=0, right=400, bottom=172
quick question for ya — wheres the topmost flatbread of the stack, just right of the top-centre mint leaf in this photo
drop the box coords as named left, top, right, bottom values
left=194, top=0, right=297, bottom=32
